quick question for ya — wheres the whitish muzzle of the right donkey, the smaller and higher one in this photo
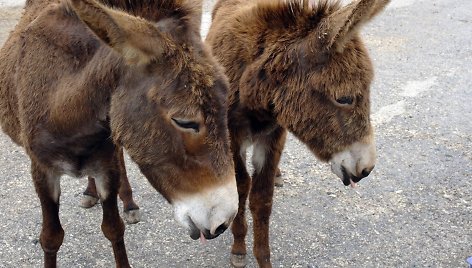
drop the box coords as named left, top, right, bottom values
left=330, top=136, right=376, bottom=187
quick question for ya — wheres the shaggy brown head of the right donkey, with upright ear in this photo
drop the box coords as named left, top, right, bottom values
left=242, top=0, right=389, bottom=186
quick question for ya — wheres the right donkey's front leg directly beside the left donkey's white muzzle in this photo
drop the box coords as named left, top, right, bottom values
left=231, top=139, right=251, bottom=267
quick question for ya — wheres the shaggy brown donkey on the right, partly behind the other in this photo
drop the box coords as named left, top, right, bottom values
left=206, top=0, right=389, bottom=267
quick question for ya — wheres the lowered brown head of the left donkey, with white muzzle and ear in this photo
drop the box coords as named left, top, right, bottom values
left=70, top=0, right=238, bottom=239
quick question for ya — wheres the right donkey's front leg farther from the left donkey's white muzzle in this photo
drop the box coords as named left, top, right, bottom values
left=249, top=128, right=286, bottom=268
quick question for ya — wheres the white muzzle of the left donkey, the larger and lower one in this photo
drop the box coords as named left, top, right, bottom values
left=172, top=175, right=238, bottom=239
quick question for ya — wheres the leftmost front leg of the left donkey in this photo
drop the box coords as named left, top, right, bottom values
left=31, top=161, right=64, bottom=268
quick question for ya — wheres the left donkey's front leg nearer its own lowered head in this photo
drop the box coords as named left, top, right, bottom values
left=95, top=149, right=130, bottom=268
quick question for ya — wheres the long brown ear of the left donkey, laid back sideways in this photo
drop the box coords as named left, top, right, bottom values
left=69, top=0, right=167, bottom=65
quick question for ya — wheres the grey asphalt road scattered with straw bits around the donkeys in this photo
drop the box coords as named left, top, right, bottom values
left=0, top=0, right=472, bottom=267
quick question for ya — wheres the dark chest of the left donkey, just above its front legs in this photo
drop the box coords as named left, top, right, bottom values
left=30, top=120, right=114, bottom=177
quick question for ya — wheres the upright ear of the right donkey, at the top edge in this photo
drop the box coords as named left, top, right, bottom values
left=320, top=0, right=390, bottom=51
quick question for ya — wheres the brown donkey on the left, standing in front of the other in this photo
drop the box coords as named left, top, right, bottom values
left=0, top=0, right=238, bottom=267
